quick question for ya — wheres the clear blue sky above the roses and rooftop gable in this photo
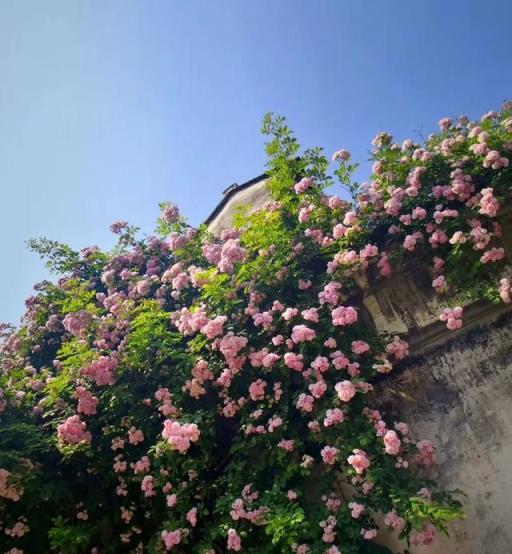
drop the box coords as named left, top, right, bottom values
left=0, top=0, right=512, bottom=322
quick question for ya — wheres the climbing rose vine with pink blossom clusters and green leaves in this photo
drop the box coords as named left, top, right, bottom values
left=0, top=104, right=512, bottom=554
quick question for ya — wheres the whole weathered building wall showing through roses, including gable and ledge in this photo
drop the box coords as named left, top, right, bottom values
left=210, top=179, right=512, bottom=554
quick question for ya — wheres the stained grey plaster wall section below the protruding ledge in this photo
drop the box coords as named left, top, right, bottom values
left=376, top=313, right=512, bottom=554
